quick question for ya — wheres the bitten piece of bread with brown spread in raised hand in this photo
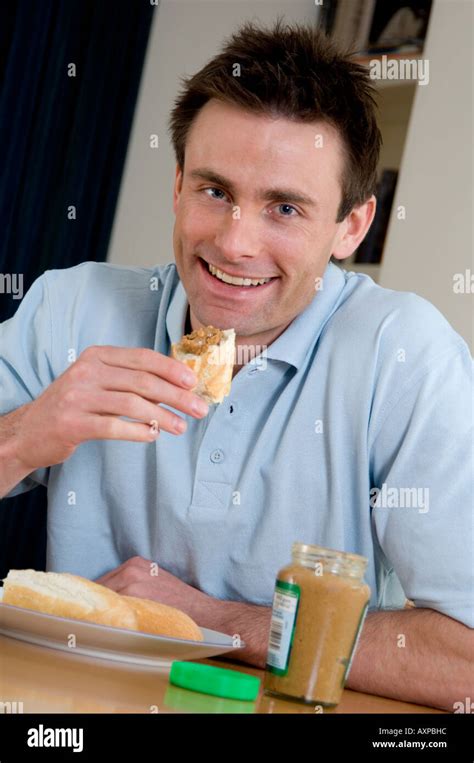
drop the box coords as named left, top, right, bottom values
left=171, top=326, right=235, bottom=403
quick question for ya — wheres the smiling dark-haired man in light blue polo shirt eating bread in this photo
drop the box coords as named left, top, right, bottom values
left=0, top=22, right=474, bottom=710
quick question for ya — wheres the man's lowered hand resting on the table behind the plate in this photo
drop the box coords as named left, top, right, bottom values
left=94, top=556, right=215, bottom=628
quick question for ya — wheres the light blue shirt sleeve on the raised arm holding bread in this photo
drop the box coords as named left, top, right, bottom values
left=0, top=273, right=54, bottom=498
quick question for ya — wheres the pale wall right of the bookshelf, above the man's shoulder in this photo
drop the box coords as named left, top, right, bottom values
left=379, top=0, right=474, bottom=352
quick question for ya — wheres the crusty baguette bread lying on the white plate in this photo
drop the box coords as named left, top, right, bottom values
left=3, top=570, right=203, bottom=641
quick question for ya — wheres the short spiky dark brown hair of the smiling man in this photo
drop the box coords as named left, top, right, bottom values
left=169, top=18, right=382, bottom=222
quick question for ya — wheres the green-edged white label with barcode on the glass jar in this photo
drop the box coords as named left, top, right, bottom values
left=267, top=580, right=301, bottom=676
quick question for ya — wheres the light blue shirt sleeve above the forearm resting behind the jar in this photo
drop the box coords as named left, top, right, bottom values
left=369, top=341, right=474, bottom=628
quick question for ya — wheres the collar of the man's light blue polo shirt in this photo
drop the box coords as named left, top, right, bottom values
left=166, top=262, right=346, bottom=369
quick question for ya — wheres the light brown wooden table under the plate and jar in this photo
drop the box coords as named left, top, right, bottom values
left=0, top=636, right=443, bottom=714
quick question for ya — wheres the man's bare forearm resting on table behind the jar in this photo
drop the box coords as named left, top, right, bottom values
left=201, top=599, right=474, bottom=712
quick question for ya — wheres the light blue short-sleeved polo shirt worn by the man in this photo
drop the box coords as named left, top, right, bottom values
left=0, top=262, right=474, bottom=628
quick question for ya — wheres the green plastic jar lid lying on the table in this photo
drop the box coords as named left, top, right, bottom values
left=169, top=661, right=260, bottom=700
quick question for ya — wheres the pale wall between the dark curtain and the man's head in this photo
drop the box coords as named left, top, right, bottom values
left=107, top=0, right=319, bottom=267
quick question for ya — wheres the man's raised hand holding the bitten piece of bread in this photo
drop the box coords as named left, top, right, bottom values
left=5, top=345, right=209, bottom=474
